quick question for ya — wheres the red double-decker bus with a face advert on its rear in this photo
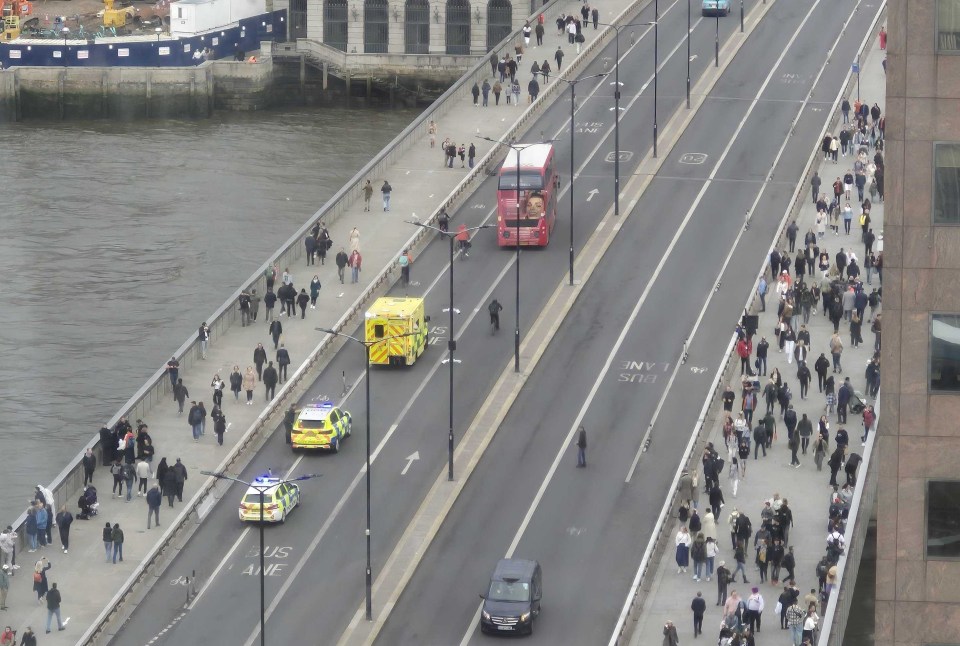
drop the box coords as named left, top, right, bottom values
left=497, top=144, right=560, bottom=247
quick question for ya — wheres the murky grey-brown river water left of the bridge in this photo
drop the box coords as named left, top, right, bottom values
left=0, top=108, right=418, bottom=526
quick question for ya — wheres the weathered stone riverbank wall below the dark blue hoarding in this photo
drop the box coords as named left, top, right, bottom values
left=0, top=47, right=274, bottom=123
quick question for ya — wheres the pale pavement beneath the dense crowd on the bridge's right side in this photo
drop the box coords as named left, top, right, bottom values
left=630, top=34, right=886, bottom=646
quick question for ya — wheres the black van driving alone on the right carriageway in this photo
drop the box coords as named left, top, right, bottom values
left=480, top=559, right=543, bottom=634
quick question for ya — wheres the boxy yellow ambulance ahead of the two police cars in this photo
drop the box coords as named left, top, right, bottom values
left=364, top=296, right=430, bottom=366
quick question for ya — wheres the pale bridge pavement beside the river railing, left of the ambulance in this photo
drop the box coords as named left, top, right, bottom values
left=0, top=0, right=644, bottom=645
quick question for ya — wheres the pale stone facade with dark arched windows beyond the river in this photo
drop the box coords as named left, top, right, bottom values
left=290, top=0, right=539, bottom=55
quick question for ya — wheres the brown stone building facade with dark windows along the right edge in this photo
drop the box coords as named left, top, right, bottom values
left=880, top=0, right=960, bottom=646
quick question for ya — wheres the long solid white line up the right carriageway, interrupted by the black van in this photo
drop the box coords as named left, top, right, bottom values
left=460, top=0, right=836, bottom=646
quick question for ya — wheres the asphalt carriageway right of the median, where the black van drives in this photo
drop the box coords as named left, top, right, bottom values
left=378, top=0, right=873, bottom=645
